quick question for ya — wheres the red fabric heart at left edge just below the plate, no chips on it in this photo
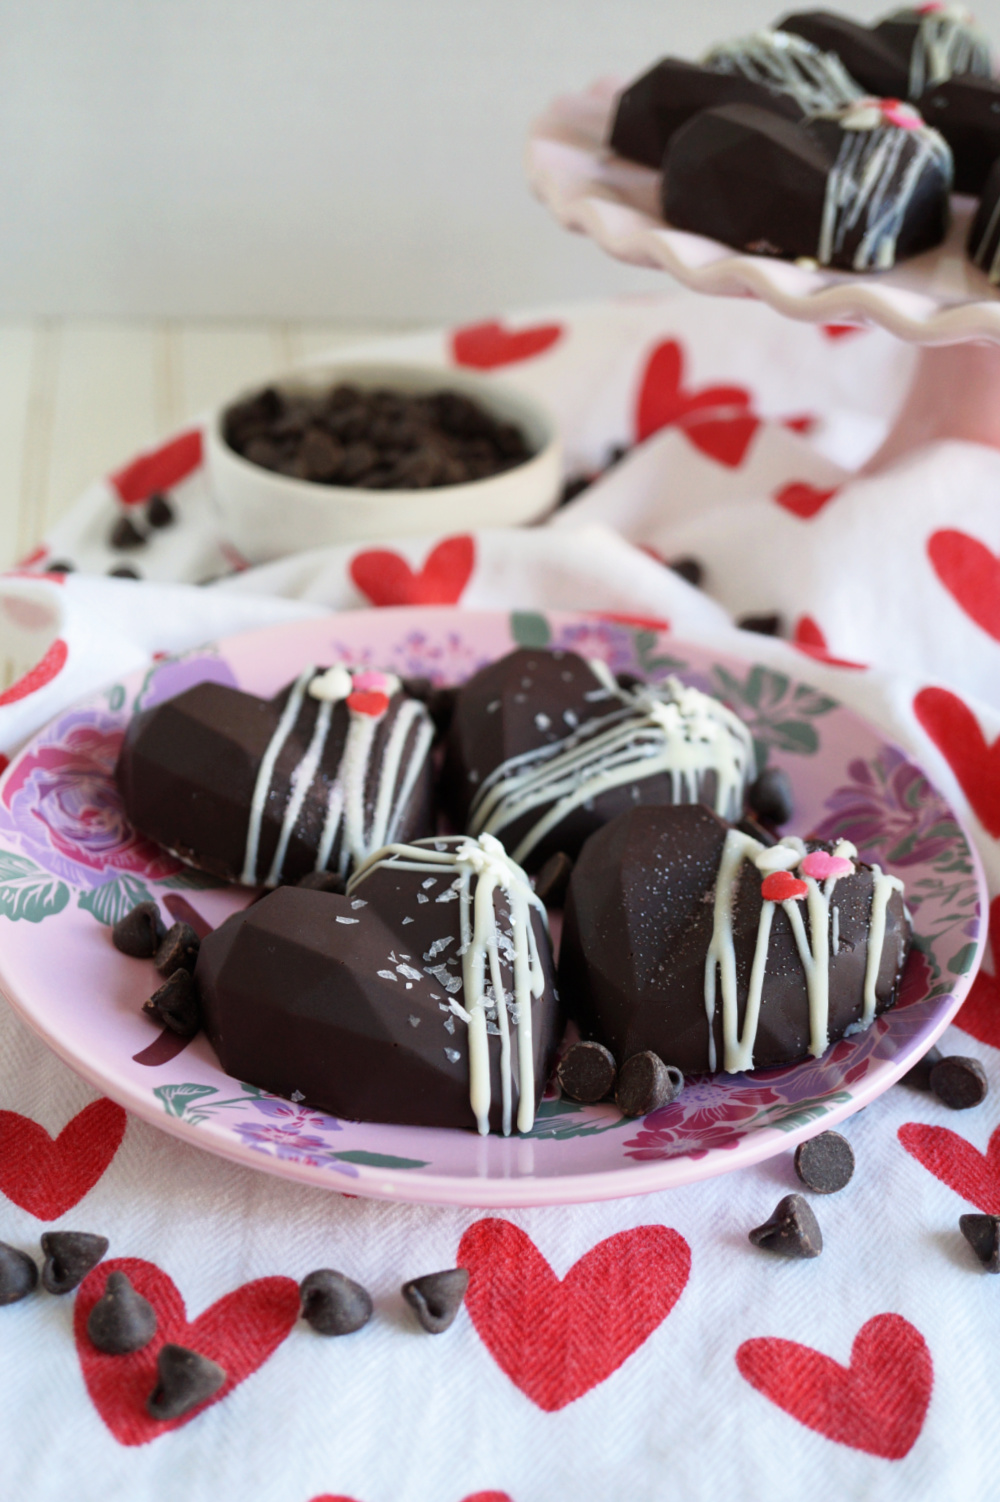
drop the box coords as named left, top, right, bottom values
left=0, top=1099, right=128, bottom=1220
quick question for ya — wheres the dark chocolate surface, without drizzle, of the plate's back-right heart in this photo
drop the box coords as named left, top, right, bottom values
left=441, top=647, right=732, bottom=871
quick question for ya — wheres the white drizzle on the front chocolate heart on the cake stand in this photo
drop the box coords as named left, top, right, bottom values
left=817, top=99, right=953, bottom=272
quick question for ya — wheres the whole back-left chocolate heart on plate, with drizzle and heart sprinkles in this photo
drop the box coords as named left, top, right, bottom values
left=116, top=667, right=434, bottom=886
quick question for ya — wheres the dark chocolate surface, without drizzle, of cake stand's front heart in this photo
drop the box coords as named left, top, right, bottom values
left=662, top=104, right=947, bottom=270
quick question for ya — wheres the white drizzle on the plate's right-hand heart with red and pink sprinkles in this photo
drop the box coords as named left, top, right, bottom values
left=704, top=829, right=902, bottom=1074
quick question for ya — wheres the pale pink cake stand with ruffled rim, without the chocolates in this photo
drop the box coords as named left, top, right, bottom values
left=527, top=78, right=1000, bottom=472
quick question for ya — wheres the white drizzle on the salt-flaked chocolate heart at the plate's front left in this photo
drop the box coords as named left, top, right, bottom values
left=347, top=835, right=548, bottom=1137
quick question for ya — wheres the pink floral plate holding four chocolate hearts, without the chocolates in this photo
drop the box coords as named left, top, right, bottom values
left=0, top=608, right=986, bottom=1206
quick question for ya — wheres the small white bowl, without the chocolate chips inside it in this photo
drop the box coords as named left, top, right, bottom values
left=206, top=360, right=562, bottom=563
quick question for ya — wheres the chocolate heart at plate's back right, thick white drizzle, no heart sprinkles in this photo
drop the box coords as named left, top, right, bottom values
left=441, top=647, right=754, bottom=871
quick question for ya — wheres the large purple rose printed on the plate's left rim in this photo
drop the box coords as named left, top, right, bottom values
left=0, top=709, right=183, bottom=886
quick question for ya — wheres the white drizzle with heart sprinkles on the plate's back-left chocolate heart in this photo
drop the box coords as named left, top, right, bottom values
left=240, top=664, right=434, bottom=886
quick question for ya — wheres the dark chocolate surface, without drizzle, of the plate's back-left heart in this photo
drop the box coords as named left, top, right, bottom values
left=116, top=683, right=434, bottom=882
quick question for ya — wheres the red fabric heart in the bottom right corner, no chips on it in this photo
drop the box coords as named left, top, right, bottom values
left=736, top=1314, right=934, bottom=1460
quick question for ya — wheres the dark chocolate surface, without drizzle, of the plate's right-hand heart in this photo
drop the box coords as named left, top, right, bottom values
left=559, top=805, right=910, bottom=1074
